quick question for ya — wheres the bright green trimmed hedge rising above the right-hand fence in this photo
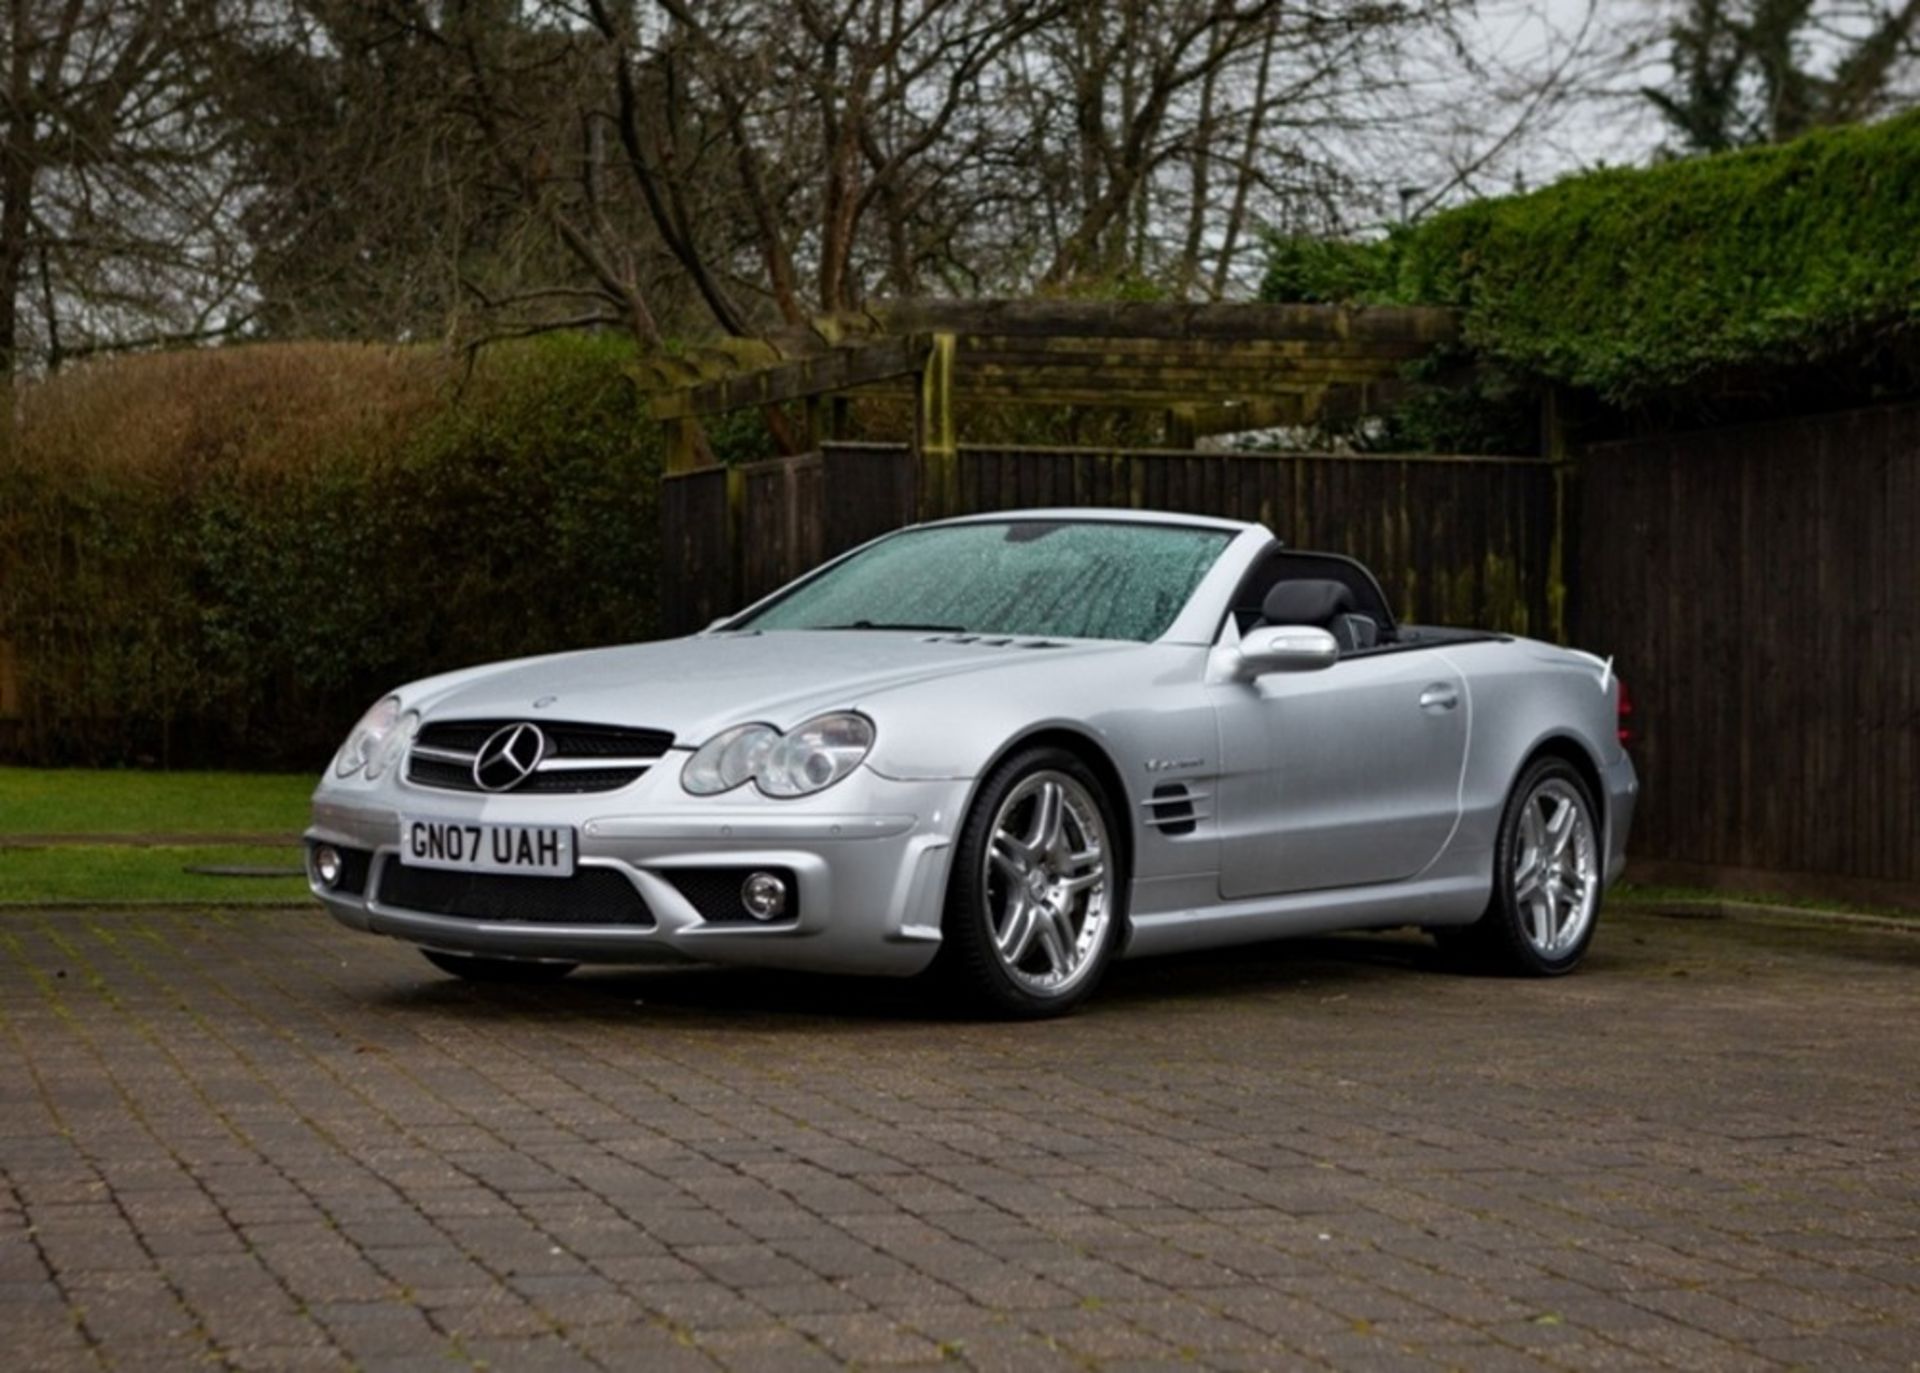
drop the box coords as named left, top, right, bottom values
left=1265, top=115, right=1920, bottom=401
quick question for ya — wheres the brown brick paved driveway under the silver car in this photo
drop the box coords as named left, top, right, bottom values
left=0, top=912, right=1920, bottom=1371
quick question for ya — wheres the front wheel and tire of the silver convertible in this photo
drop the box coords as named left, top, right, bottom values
left=935, top=749, right=1127, bottom=1020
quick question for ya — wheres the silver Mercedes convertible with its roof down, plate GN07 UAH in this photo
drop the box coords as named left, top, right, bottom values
left=305, top=509, right=1636, bottom=1016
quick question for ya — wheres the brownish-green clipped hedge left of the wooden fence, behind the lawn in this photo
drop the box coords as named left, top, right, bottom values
left=0, top=336, right=675, bottom=766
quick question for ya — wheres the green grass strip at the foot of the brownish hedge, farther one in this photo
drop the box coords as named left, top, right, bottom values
left=0, top=768, right=315, bottom=835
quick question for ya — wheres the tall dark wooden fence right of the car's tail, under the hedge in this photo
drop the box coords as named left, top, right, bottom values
left=1574, top=405, right=1920, bottom=903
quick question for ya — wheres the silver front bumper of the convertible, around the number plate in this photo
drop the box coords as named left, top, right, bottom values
left=305, top=753, right=972, bottom=976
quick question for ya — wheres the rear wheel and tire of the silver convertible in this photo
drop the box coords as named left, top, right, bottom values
left=1434, top=759, right=1607, bottom=977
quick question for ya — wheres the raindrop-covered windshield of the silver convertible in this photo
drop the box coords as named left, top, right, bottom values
left=728, top=520, right=1233, bottom=641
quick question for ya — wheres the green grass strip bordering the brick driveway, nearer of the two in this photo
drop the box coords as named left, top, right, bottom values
left=0, top=845, right=307, bottom=904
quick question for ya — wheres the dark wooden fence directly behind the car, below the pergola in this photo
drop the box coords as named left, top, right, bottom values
left=660, top=444, right=1563, bottom=638
